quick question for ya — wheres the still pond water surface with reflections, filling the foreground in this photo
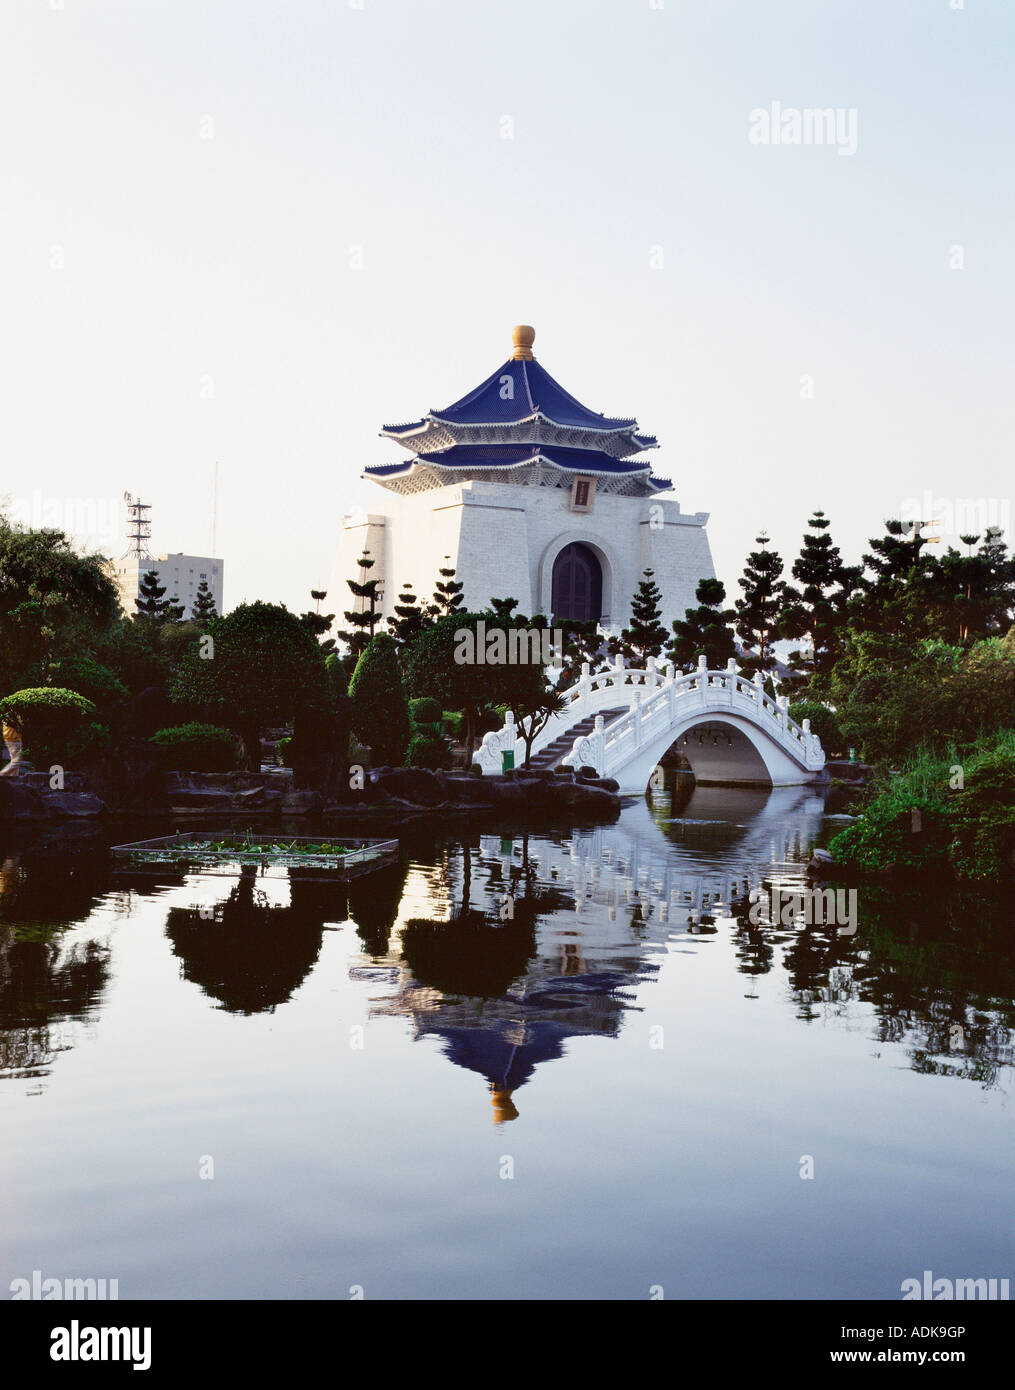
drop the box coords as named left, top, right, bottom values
left=0, top=788, right=1015, bottom=1298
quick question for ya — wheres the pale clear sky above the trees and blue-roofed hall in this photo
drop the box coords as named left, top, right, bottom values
left=0, top=0, right=1015, bottom=612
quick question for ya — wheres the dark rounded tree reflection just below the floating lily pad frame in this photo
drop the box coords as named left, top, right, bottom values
left=165, top=865, right=326, bottom=1013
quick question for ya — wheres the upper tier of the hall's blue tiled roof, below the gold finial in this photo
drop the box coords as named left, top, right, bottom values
left=384, top=357, right=655, bottom=448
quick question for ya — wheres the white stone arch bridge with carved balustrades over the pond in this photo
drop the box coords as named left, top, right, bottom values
left=476, top=657, right=825, bottom=796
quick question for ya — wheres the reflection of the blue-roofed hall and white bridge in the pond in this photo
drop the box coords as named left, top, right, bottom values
left=367, top=788, right=822, bottom=1123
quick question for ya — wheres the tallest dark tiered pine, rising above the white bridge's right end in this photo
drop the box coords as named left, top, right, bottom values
left=779, top=510, right=862, bottom=688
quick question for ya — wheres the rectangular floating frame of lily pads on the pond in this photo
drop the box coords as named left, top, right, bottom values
left=111, top=830, right=398, bottom=878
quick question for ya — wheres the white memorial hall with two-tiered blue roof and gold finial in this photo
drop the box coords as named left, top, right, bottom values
left=332, top=325, right=715, bottom=632
